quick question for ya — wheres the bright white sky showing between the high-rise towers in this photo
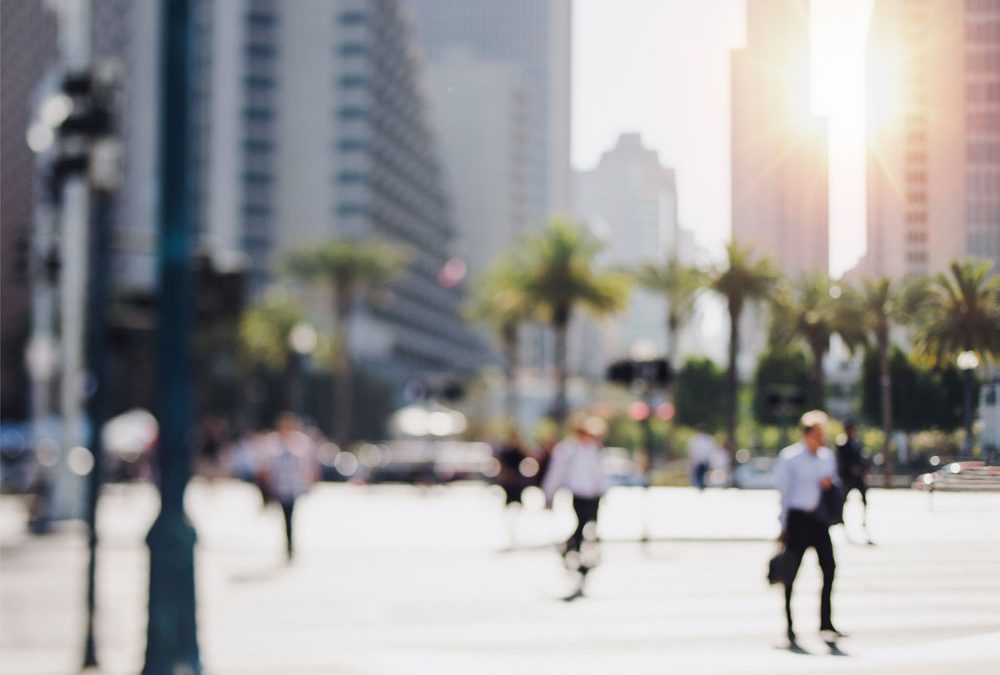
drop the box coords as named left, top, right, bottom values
left=572, top=0, right=872, bottom=276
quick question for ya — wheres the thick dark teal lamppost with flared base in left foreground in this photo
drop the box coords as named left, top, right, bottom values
left=142, top=0, right=201, bottom=675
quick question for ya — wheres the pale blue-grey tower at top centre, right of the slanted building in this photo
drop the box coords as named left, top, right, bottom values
left=405, top=0, right=572, bottom=390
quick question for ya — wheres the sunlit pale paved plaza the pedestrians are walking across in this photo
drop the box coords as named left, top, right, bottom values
left=0, top=481, right=1000, bottom=675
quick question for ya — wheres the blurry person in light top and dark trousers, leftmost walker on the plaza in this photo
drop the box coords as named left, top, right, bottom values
left=266, top=413, right=318, bottom=562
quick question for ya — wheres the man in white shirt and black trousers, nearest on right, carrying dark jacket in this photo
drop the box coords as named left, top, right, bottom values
left=775, top=410, right=843, bottom=647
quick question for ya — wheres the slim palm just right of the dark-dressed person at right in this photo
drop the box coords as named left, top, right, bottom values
left=840, top=277, right=924, bottom=487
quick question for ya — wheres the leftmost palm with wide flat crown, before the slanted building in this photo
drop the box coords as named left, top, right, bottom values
left=285, top=238, right=410, bottom=445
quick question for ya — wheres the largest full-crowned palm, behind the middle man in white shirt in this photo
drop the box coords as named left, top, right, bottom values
left=517, top=218, right=629, bottom=421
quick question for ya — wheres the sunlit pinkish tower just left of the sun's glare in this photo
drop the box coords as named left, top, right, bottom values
left=732, top=0, right=829, bottom=277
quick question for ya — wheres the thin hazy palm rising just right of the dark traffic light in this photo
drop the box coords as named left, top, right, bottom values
left=635, top=256, right=708, bottom=456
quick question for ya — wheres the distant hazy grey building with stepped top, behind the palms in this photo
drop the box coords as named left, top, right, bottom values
left=574, top=134, right=694, bottom=364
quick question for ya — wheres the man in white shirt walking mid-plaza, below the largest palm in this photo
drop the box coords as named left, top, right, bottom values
left=542, top=416, right=611, bottom=553
